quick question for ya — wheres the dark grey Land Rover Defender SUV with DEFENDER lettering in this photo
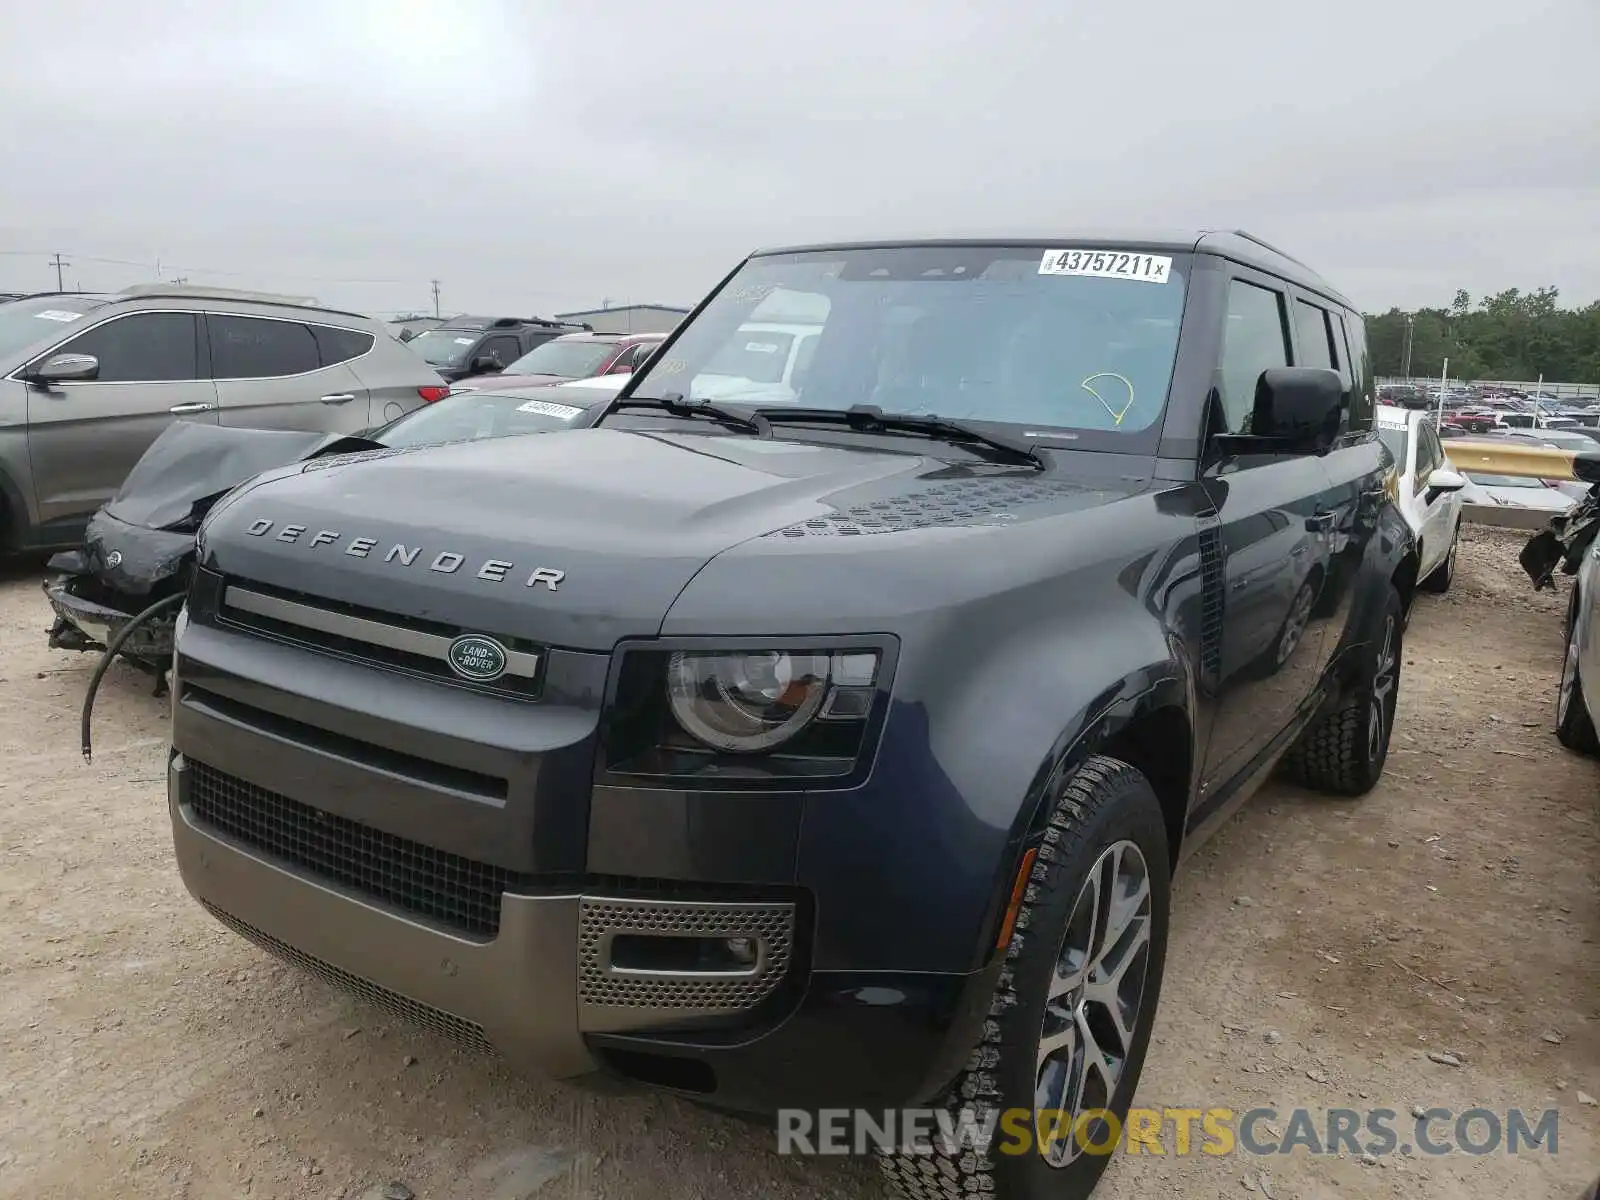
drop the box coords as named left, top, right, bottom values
left=168, top=234, right=1418, bottom=1200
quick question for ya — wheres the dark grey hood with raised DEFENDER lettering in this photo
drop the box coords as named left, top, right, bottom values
left=200, top=427, right=1142, bottom=651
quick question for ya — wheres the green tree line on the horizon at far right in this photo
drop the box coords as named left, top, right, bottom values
left=1366, top=288, right=1600, bottom=384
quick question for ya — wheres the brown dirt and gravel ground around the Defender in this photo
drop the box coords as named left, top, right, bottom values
left=0, top=530, right=1600, bottom=1200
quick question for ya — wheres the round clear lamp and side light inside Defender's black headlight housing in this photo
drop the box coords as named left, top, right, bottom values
left=667, top=650, right=878, bottom=754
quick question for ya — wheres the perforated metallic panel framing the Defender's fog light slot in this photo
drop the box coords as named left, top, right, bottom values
left=578, top=898, right=795, bottom=1013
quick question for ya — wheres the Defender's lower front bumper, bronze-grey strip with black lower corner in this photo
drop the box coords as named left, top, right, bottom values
left=168, top=754, right=998, bottom=1112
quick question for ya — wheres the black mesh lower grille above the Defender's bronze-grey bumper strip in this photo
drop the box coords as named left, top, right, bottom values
left=189, top=760, right=528, bottom=938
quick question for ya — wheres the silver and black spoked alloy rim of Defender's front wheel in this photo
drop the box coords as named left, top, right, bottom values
left=1034, top=840, right=1152, bottom=1166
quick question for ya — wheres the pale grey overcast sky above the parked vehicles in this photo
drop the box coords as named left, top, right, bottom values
left=0, top=0, right=1600, bottom=314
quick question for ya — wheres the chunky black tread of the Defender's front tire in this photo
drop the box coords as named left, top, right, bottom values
left=878, top=755, right=1165, bottom=1200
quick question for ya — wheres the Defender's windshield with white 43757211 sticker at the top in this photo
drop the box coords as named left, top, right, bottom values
left=620, top=245, right=1189, bottom=445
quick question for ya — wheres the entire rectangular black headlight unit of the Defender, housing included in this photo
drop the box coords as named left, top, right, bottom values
left=602, top=642, right=894, bottom=787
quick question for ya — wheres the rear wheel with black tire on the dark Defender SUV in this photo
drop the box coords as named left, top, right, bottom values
left=1283, top=586, right=1405, bottom=797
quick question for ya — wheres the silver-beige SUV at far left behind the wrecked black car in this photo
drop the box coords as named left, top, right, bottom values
left=0, top=283, right=446, bottom=552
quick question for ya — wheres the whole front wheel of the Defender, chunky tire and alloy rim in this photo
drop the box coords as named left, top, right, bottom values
left=880, top=755, right=1171, bottom=1200
